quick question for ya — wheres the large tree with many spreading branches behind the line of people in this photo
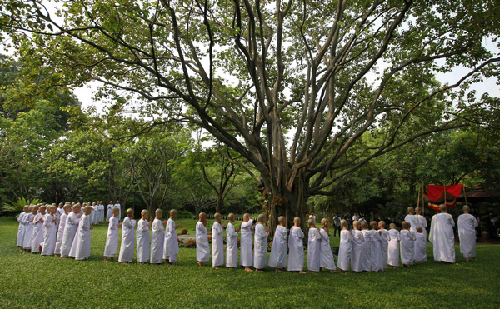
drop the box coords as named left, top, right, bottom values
left=0, top=0, right=500, bottom=229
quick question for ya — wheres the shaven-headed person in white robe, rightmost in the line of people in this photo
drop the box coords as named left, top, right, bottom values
left=457, top=205, right=478, bottom=262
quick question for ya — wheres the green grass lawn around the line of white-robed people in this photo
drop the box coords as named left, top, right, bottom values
left=0, top=218, right=500, bottom=308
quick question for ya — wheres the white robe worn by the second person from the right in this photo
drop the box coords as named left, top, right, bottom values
left=429, top=213, right=455, bottom=263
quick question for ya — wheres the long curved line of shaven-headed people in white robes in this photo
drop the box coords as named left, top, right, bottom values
left=17, top=203, right=477, bottom=273
